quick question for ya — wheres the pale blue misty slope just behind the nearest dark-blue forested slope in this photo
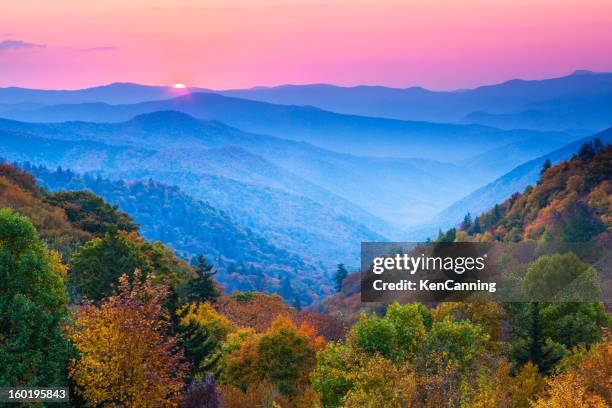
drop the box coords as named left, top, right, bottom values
left=0, top=127, right=384, bottom=265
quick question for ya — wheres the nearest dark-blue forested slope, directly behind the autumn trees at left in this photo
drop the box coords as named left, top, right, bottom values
left=21, top=165, right=326, bottom=304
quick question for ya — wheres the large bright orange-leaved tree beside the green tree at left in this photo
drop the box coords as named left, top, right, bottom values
left=69, top=271, right=187, bottom=407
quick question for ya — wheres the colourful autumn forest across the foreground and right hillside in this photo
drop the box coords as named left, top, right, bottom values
left=0, top=140, right=612, bottom=408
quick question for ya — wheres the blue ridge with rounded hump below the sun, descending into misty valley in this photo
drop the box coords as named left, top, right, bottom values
left=0, top=111, right=557, bottom=226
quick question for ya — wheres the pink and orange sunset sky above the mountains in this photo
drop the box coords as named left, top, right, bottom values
left=0, top=0, right=612, bottom=89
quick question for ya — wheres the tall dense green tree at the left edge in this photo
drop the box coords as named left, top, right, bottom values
left=0, top=209, right=68, bottom=387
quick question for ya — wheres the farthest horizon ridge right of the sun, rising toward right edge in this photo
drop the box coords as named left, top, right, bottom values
left=217, top=70, right=612, bottom=135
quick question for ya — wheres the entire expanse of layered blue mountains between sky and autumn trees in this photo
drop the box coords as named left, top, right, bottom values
left=0, top=72, right=612, bottom=304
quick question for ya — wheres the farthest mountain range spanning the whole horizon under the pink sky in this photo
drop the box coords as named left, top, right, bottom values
left=0, top=70, right=612, bottom=136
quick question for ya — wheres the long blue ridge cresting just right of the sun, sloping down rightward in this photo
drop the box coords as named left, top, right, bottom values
left=0, top=93, right=572, bottom=161
